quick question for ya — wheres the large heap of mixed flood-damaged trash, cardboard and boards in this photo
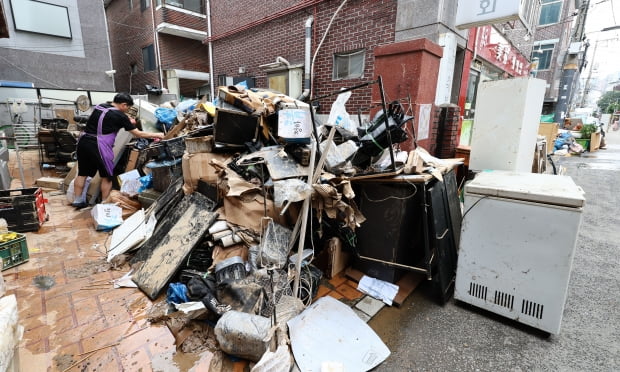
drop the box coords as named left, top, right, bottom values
left=97, top=86, right=456, bottom=371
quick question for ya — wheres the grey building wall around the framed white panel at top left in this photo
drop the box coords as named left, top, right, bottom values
left=0, top=0, right=113, bottom=90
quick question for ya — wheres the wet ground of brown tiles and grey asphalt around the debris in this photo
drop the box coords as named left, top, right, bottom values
left=2, top=126, right=620, bottom=371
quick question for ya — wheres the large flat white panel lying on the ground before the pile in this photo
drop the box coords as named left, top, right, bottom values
left=287, top=296, right=390, bottom=372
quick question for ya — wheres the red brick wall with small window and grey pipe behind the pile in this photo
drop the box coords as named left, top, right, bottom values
left=211, top=0, right=397, bottom=114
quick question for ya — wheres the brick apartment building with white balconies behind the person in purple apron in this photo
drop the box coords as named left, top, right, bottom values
left=106, top=0, right=210, bottom=98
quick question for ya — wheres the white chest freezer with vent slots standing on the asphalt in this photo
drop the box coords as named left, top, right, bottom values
left=454, top=171, right=585, bottom=334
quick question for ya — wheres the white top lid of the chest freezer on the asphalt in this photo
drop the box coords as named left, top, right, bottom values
left=465, top=171, right=586, bottom=207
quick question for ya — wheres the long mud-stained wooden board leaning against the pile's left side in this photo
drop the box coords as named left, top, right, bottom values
left=133, top=193, right=218, bottom=299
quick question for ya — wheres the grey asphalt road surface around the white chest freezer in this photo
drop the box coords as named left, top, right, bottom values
left=369, top=127, right=620, bottom=371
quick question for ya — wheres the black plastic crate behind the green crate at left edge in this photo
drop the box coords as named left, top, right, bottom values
left=0, top=187, right=47, bottom=232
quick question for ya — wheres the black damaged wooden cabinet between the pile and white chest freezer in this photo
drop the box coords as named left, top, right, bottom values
left=352, top=169, right=461, bottom=304
